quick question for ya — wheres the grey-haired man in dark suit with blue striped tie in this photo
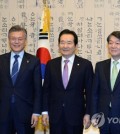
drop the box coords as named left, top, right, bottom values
left=0, top=25, right=42, bottom=134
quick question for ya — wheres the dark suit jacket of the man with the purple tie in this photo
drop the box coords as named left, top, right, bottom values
left=43, top=56, right=93, bottom=125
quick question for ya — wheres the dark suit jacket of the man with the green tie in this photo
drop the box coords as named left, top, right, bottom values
left=92, top=59, right=120, bottom=117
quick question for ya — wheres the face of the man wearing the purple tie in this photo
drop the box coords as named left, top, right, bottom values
left=59, top=34, right=76, bottom=58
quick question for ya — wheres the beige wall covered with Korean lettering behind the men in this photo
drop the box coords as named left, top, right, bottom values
left=0, top=0, right=120, bottom=65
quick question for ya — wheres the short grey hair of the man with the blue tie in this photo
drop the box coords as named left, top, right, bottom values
left=8, top=25, right=27, bottom=38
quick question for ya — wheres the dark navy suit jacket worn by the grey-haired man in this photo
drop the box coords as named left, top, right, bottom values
left=0, top=52, right=42, bottom=122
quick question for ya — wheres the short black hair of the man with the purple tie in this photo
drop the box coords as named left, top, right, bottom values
left=58, top=29, right=78, bottom=46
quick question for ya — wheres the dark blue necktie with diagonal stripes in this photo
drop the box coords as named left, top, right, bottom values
left=11, top=55, right=19, bottom=85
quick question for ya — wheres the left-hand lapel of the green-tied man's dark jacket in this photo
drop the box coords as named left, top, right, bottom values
left=104, top=59, right=111, bottom=91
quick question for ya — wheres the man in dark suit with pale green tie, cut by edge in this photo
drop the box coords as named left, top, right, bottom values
left=92, top=31, right=120, bottom=134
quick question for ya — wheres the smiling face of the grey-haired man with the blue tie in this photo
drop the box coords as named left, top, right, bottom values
left=9, top=31, right=26, bottom=52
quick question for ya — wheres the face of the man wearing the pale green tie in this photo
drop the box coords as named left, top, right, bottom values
left=108, top=36, right=120, bottom=60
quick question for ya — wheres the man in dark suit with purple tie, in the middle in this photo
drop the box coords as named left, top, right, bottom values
left=42, top=29, right=93, bottom=134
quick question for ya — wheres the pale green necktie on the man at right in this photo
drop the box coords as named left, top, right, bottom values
left=111, top=61, right=119, bottom=89
